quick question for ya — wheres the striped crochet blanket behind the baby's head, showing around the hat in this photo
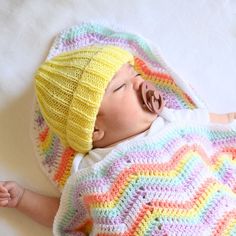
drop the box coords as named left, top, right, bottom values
left=31, top=22, right=205, bottom=191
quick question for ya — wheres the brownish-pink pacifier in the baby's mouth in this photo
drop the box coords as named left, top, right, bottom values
left=141, top=81, right=164, bottom=114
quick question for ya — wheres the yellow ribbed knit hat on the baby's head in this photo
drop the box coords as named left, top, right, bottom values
left=35, top=45, right=134, bottom=154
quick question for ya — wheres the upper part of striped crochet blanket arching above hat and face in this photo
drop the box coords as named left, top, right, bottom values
left=48, top=23, right=199, bottom=109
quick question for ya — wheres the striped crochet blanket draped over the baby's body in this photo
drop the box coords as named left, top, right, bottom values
left=54, top=122, right=236, bottom=236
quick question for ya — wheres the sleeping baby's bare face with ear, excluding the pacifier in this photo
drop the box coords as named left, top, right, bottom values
left=93, top=63, right=157, bottom=147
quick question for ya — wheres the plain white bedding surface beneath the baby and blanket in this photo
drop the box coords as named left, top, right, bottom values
left=0, top=0, right=236, bottom=236
